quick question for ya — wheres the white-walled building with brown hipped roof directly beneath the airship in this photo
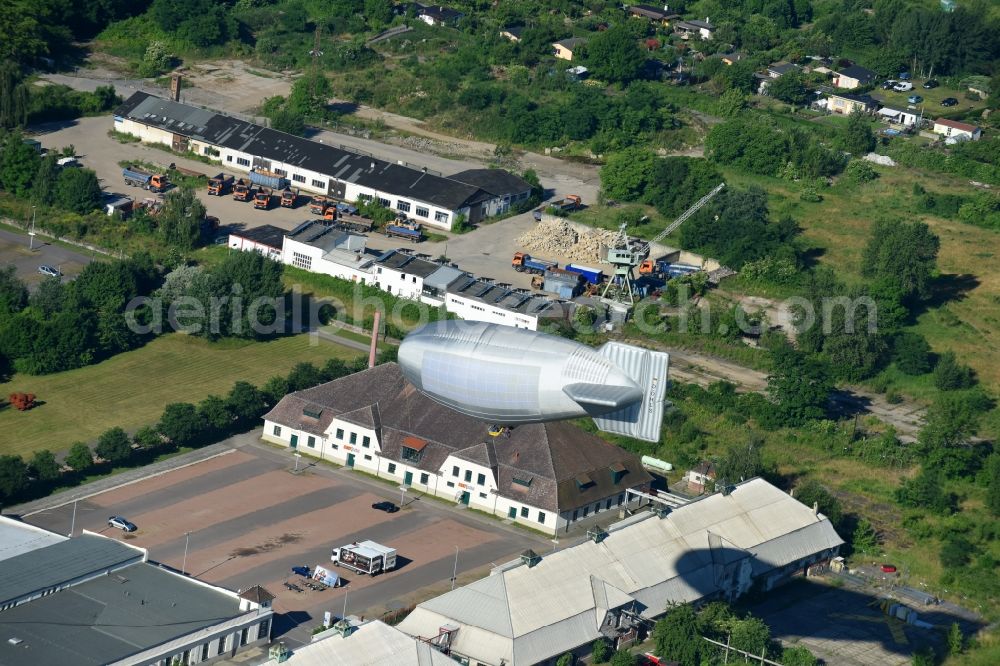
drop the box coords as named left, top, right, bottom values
left=262, top=363, right=652, bottom=534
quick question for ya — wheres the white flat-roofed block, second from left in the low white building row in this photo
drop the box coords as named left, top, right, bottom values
left=281, top=220, right=376, bottom=284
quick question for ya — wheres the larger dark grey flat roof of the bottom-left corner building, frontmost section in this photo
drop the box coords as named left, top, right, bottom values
left=0, top=560, right=243, bottom=666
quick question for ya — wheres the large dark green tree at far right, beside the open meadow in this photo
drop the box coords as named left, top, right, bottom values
left=861, top=220, right=941, bottom=302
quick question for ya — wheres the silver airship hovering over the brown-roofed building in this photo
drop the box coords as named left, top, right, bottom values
left=398, top=320, right=669, bottom=442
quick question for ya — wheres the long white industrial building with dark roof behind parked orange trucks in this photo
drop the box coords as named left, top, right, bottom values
left=114, top=92, right=531, bottom=230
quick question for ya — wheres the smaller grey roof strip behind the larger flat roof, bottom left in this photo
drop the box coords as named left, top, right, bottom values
left=0, top=534, right=146, bottom=606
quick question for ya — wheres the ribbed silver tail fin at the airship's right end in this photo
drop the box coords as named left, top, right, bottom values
left=594, top=342, right=670, bottom=442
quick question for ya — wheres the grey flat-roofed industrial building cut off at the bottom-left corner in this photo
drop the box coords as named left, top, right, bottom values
left=0, top=517, right=274, bottom=666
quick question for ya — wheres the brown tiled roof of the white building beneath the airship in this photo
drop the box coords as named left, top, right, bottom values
left=264, top=363, right=652, bottom=512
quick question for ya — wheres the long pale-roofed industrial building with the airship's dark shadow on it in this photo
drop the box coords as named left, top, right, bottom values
left=399, top=479, right=843, bottom=666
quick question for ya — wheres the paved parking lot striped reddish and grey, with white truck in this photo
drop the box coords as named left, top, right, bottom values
left=26, top=444, right=552, bottom=644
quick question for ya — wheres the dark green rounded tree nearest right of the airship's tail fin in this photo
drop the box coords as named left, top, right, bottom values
left=767, top=341, right=833, bottom=426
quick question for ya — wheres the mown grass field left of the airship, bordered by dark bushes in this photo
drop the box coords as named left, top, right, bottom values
left=0, top=333, right=358, bottom=456
